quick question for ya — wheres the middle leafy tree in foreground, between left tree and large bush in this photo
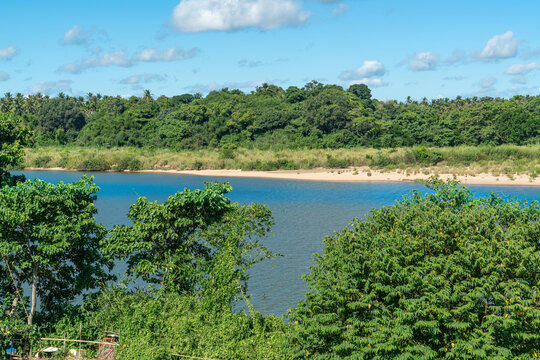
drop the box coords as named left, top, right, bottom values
left=103, top=183, right=273, bottom=308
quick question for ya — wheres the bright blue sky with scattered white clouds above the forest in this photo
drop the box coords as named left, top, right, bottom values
left=0, top=0, right=540, bottom=100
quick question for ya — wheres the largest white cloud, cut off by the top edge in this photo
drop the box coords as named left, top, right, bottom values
left=170, top=0, right=309, bottom=33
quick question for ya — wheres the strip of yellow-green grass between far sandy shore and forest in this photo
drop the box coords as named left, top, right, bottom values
left=20, top=145, right=540, bottom=178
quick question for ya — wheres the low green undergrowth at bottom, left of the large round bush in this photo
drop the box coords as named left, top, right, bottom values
left=52, top=286, right=287, bottom=360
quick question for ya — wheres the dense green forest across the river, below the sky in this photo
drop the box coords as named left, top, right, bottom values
left=0, top=81, right=540, bottom=150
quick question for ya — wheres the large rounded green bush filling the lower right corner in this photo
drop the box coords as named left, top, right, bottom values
left=289, top=181, right=540, bottom=359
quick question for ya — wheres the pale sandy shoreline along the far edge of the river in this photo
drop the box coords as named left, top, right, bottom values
left=24, top=167, right=540, bottom=186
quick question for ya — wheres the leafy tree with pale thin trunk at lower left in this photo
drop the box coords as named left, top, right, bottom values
left=0, top=177, right=110, bottom=324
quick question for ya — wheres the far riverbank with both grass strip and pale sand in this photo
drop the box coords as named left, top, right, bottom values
left=25, top=145, right=540, bottom=186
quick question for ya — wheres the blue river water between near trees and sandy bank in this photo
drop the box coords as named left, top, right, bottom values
left=14, top=171, right=540, bottom=315
